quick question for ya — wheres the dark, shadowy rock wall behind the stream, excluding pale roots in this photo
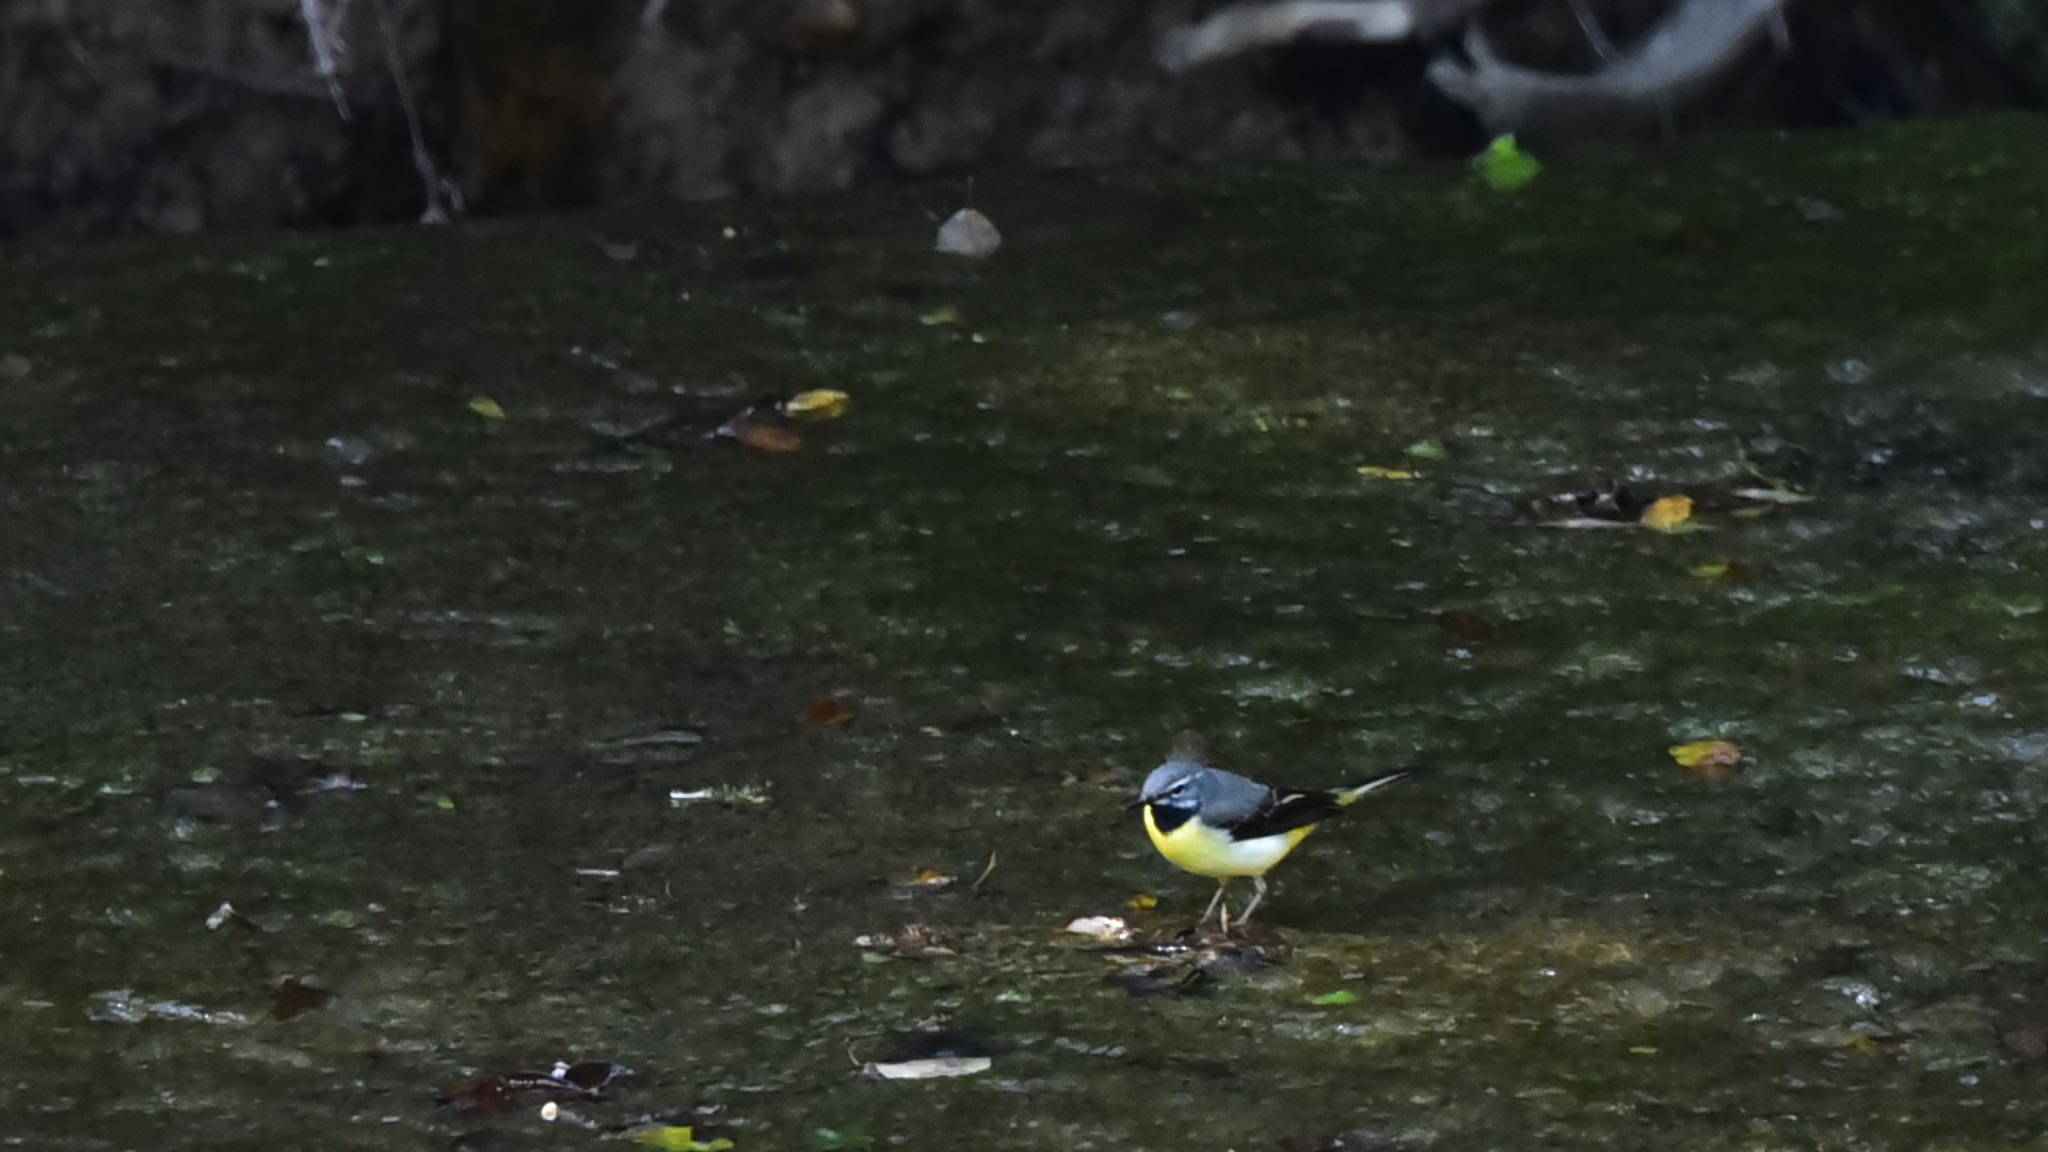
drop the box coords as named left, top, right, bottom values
left=0, top=0, right=2048, bottom=236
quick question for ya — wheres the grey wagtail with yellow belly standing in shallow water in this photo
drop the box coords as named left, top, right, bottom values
left=1128, top=746, right=1419, bottom=935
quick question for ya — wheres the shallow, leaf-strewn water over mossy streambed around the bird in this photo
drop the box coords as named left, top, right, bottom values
left=0, top=121, right=2048, bottom=1152
